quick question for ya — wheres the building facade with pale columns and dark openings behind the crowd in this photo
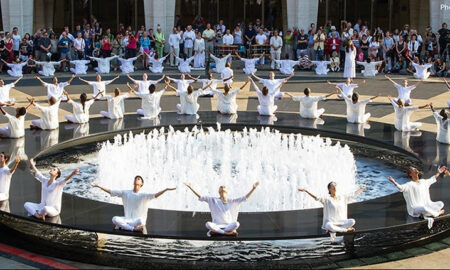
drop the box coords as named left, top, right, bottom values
left=0, top=0, right=450, bottom=35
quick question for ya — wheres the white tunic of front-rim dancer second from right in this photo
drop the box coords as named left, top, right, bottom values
left=317, top=194, right=354, bottom=230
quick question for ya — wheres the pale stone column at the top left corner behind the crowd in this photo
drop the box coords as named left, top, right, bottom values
left=1, top=0, right=34, bottom=36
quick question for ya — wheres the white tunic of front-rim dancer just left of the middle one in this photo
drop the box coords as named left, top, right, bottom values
left=111, top=190, right=156, bottom=225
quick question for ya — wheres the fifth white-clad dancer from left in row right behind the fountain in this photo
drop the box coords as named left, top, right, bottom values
left=127, top=81, right=170, bottom=119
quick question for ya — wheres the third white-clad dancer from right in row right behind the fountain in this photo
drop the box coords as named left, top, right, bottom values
left=340, top=90, right=379, bottom=124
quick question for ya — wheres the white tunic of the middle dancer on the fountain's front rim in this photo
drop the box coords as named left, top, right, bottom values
left=199, top=196, right=247, bottom=226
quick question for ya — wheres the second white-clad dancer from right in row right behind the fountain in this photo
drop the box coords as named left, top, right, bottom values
left=388, top=97, right=430, bottom=131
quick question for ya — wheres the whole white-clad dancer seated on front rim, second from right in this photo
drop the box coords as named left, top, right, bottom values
left=298, top=182, right=366, bottom=237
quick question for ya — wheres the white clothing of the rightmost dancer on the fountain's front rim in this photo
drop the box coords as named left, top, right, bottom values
left=398, top=176, right=443, bottom=217
